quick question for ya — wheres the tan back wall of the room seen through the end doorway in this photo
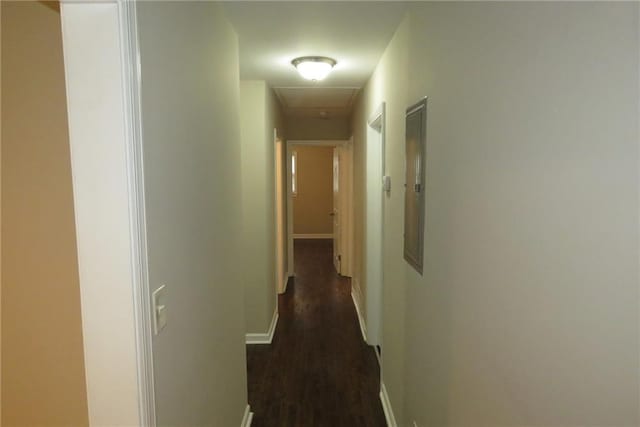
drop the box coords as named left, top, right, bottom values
left=292, top=145, right=333, bottom=234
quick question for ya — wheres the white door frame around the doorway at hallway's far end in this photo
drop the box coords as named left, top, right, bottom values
left=286, top=138, right=353, bottom=277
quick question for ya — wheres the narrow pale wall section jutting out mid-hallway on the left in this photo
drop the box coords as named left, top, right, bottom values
left=240, top=80, right=286, bottom=333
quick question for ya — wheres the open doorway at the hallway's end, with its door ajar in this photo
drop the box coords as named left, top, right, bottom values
left=287, top=140, right=353, bottom=277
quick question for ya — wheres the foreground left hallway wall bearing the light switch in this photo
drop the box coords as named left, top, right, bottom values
left=138, top=2, right=247, bottom=426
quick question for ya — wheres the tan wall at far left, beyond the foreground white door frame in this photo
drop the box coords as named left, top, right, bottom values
left=2, top=2, right=88, bottom=426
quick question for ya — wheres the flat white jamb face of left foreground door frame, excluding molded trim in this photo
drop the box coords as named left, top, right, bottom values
left=61, top=3, right=141, bottom=425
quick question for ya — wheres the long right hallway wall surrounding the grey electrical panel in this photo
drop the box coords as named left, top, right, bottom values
left=354, top=3, right=640, bottom=426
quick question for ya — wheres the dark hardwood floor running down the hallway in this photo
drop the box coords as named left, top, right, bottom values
left=247, top=240, right=386, bottom=427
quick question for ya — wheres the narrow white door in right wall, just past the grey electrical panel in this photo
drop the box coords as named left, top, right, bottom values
left=365, top=104, right=384, bottom=346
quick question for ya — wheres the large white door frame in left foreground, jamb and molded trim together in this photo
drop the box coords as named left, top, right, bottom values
left=60, top=0, right=156, bottom=427
